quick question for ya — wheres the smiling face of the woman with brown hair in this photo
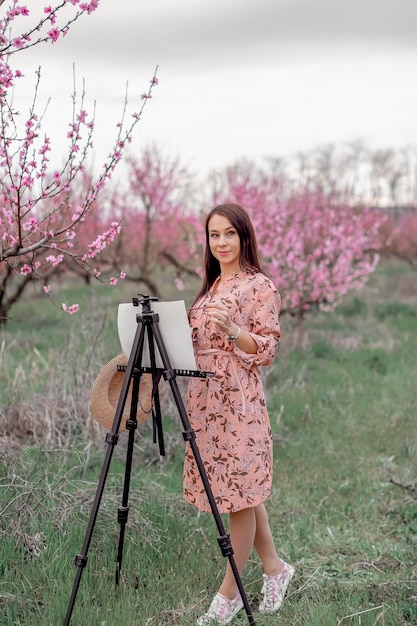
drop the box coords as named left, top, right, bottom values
left=207, top=213, right=240, bottom=274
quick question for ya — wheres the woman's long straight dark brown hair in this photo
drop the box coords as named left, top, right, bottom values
left=194, top=203, right=264, bottom=303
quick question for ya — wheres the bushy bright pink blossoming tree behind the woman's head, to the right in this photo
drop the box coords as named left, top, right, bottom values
left=213, top=162, right=382, bottom=319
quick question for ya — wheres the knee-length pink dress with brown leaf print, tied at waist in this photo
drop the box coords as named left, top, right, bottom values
left=184, top=271, right=281, bottom=513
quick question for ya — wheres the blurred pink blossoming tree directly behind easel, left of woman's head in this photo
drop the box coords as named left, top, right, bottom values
left=101, top=146, right=200, bottom=297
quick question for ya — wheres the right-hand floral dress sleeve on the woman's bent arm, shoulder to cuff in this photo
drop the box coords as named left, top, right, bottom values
left=234, top=276, right=281, bottom=368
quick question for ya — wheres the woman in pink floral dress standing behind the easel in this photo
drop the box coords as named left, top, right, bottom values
left=184, top=204, right=294, bottom=626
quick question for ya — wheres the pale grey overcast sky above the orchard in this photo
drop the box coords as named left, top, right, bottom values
left=16, top=0, right=417, bottom=173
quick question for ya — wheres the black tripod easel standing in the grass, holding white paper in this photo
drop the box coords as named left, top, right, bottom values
left=64, top=294, right=256, bottom=626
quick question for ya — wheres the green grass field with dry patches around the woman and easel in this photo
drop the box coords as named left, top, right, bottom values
left=0, top=263, right=417, bottom=626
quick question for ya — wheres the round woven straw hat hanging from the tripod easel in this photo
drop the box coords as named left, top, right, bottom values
left=91, top=354, right=152, bottom=431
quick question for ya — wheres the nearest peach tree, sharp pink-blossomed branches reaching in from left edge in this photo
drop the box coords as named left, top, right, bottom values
left=0, top=0, right=157, bottom=324
